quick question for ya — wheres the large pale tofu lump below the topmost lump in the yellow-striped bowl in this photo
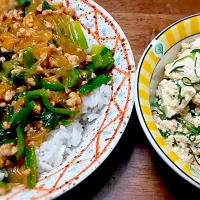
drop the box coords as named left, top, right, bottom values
left=156, top=79, right=196, bottom=118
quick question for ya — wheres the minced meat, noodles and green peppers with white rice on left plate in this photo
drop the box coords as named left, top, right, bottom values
left=0, top=0, right=114, bottom=194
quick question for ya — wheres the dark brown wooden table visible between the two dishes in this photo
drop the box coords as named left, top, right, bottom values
left=58, top=0, right=200, bottom=200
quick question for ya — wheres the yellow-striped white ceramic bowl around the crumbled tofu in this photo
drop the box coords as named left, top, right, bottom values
left=135, top=14, right=200, bottom=188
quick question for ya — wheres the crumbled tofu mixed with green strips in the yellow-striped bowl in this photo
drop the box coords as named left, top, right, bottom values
left=151, top=38, right=200, bottom=172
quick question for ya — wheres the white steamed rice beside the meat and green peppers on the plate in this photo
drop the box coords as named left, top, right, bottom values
left=35, top=85, right=111, bottom=175
